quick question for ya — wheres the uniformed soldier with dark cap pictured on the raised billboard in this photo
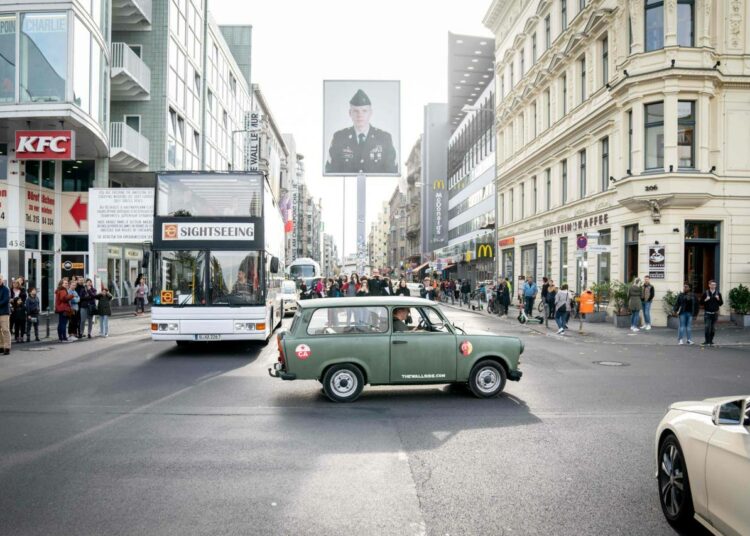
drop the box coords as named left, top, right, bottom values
left=326, top=89, right=398, bottom=175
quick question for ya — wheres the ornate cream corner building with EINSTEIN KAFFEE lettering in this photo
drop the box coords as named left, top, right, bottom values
left=484, top=0, right=750, bottom=323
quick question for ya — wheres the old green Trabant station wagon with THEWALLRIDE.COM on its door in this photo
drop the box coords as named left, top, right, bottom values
left=268, top=296, right=524, bottom=402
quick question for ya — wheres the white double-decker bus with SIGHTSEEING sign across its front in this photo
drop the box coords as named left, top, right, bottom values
left=151, top=172, right=285, bottom=344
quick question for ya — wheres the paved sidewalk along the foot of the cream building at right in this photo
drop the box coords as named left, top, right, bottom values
left=441, top=302, right=750, bottom=347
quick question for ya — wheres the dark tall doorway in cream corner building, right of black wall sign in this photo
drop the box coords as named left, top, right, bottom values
left=684, top=221, right=721, bottom=294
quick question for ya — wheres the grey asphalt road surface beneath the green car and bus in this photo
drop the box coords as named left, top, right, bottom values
left=0, top=309, right=750, bottom=536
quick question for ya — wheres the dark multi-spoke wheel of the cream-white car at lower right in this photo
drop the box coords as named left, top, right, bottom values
left=658, top=434, right=693, bottom=527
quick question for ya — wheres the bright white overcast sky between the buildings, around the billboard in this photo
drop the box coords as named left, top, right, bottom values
left=209, top=0, right=491, bottom=260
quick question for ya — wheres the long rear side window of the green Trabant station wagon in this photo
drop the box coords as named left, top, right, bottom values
left=307, top=307, right=388, bottom=335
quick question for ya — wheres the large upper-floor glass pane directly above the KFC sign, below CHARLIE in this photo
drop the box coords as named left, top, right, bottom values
left=19, top=12, right=68, bottom=102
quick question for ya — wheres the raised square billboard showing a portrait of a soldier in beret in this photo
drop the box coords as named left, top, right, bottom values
left=323, top=80, right=401, bottom=177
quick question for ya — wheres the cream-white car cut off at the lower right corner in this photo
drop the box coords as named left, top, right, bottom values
left=656, top=395, right=750, bottom=536
